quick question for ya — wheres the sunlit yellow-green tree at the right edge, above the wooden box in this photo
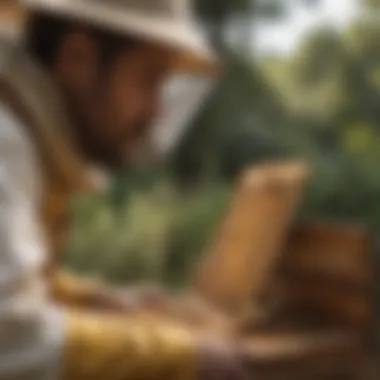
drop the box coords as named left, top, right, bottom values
left=267, top=1, right=380, bottom=226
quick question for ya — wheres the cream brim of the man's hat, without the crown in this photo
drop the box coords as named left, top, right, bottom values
left=23, top=0, right=218, bottom=75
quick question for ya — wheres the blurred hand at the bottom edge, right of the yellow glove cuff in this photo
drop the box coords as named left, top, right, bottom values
left=196, top=339, right=249, bottom=380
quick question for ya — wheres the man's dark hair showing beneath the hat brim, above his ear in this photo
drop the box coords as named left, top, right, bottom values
left=25, top=12, right=137, bottom=66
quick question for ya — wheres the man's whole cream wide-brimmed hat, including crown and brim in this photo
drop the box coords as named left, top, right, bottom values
left=21, top=0, right=217, bottom=73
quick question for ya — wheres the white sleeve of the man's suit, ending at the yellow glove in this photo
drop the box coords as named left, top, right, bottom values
left=0, top=103, right=64, bottom=380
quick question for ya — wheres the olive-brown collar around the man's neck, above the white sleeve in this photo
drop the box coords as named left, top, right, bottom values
left=0, top=33, right=108, bottom=192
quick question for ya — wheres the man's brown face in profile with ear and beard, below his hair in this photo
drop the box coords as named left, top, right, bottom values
left=57, top=30, right=174, bottom=168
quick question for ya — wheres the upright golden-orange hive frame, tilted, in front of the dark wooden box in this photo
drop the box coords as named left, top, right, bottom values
left=196, top=163, right=307, bottom=313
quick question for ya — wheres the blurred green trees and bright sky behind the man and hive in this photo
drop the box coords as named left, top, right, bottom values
left=61, top=0, right=380, bottom=288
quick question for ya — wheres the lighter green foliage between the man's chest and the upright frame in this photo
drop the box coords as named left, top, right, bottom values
left=66, top=180, right=229, bottom=286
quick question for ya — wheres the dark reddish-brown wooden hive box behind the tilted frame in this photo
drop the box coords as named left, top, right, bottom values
left=280, top=222, right=375, bottom=333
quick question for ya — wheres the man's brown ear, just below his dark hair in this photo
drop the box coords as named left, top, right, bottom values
left=56, top=31, right=98, bottom=92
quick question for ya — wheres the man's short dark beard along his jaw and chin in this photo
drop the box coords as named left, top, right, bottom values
left=65, top=82, right=159, bottom=173
